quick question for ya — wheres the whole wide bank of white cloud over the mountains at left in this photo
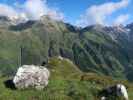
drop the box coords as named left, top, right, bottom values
left=0, top=0, right=64, bottom=21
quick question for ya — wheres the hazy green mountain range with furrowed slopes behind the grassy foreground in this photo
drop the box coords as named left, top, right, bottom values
left=0, top=16, right=133, bottom=80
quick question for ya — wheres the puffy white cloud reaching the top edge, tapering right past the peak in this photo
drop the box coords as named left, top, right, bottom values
left=23, top=0, right=64, bottom=20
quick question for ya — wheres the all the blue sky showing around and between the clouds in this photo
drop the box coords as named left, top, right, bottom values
left=0, top=0, right=133, bottom=25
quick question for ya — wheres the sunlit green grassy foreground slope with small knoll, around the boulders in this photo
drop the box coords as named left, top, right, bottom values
left=0, top=57, right=133, bottom=100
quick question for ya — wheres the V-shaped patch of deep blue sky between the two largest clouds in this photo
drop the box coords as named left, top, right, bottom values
left=48, top=0, right=123, bottom=23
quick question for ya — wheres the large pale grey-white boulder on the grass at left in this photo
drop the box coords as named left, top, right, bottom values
left=13, top=65, right=50, bottom=90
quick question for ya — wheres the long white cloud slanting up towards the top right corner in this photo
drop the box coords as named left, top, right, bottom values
left=76, top=0, right=129, bottom=26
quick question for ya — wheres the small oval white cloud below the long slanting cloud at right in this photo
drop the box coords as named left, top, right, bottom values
left=113, top=14, right=129, bottom=25
